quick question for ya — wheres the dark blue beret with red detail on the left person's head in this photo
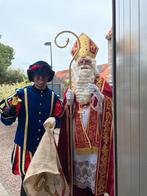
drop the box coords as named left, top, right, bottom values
left=27, top=61, right=55, bottom=82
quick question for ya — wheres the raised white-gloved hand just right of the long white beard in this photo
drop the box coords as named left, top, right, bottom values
left=88, top=83, right=104, bottom=113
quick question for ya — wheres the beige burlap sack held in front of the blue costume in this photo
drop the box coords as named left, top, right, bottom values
left=23, top=117, right=69, bottom=196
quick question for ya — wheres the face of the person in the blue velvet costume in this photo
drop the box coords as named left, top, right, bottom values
left=33, top=74, right=48, bottom=90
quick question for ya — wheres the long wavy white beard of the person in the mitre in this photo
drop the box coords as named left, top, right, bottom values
left=72, top=67, right=95, bottom=104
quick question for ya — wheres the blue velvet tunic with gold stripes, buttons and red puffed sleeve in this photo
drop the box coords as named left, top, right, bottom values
left=1, top=86, right=63, bottom=174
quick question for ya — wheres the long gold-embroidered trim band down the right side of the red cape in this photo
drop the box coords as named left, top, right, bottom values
left=96, top=98, right=112, bottom=196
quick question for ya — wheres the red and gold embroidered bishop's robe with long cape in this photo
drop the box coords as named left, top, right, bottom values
left=58, top=76, right=114, bottom=196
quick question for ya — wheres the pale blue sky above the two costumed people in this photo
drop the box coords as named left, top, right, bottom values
left=0, top=0, right=112, bottom=71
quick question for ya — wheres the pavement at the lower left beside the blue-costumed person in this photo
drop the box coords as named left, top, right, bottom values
left=0, top=122, right=20, bottom=196
